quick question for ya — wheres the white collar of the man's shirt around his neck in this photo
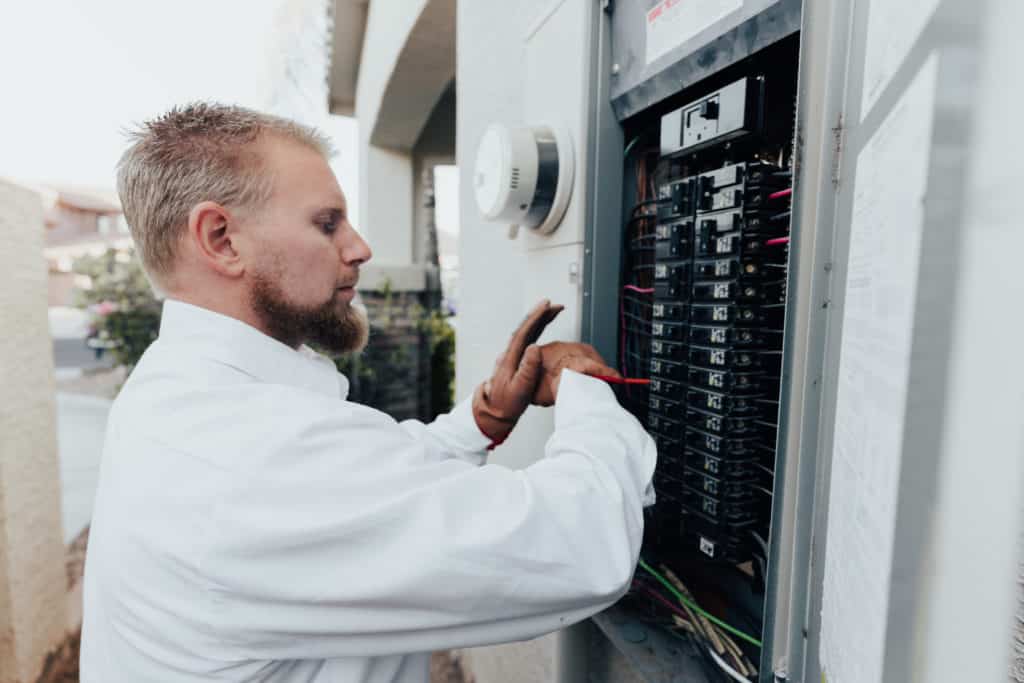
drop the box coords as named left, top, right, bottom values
left=160, top=299, right=348, bottom=399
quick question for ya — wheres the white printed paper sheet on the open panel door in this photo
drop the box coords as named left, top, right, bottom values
left=820, top=55, right=937, bottom=683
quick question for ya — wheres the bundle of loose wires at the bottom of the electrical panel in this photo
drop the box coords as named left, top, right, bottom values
left=631, top=558, right=761, bottom=683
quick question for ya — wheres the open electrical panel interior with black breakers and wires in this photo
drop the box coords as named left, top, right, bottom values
left=618, top=34, right=799, bottom=680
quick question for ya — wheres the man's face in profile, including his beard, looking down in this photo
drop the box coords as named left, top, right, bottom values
left=244, top=137, right=371, bottom=352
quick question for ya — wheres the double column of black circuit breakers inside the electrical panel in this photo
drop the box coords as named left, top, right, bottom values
left=647, top=163, right=790, bottom=562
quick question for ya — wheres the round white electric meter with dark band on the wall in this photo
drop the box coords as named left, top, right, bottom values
left=473, top=124, right=574, bottom=233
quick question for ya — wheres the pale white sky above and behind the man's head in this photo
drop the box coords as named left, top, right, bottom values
left=0, top=0, right=358, bottom=224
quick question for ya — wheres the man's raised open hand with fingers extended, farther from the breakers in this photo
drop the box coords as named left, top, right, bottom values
left=473, top=300, right=562, bottom=443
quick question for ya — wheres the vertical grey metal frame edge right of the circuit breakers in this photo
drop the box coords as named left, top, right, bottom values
left=760, top=0, right=849, bottom=683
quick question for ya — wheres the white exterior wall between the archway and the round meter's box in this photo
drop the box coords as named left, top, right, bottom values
left=456, top=0, right=556, bottom=683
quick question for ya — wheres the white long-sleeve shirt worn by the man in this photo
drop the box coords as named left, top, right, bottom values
left=81, top=301, right=655, bottom=683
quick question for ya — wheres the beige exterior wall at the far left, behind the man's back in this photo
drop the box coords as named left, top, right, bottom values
left=0, top=181, right=67, bottom=683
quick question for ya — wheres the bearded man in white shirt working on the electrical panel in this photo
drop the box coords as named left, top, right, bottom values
left=81, top=104, right=655, bottom=683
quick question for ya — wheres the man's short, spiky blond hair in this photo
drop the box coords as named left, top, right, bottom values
left=118, top=102, right=333, bottom=285
